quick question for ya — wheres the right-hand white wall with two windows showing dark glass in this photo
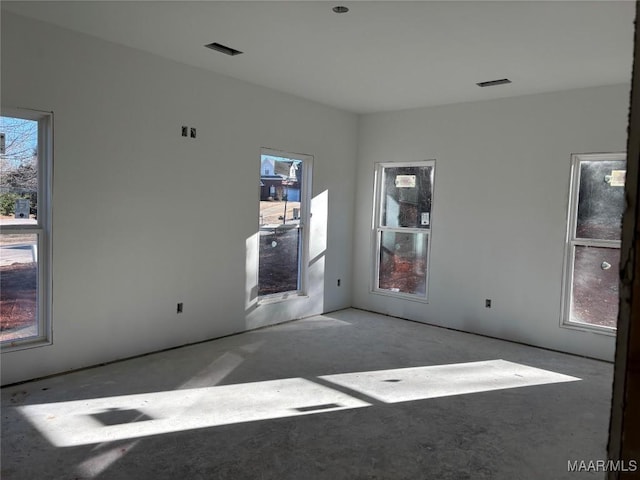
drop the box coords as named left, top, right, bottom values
left=354, top=85, right=629, bottom=360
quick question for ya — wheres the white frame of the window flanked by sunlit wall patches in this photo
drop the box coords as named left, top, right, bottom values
left=255, top=147, right=313, bottom=304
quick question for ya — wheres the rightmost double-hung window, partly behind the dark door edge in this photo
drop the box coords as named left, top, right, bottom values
left=562, top=154, right=626, bottom=333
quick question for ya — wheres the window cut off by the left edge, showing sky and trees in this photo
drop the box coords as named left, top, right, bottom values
left=0, top=109, right=52, bottom=351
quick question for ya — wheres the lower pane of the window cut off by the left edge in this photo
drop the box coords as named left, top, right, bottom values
left=0, top=234, right=38, bottom=342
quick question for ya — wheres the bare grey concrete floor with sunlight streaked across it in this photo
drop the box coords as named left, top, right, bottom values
left=1, top=309, right=613, bottom=480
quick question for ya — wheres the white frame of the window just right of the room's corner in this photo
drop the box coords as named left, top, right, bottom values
left=370, top=160, right=436, bottom=303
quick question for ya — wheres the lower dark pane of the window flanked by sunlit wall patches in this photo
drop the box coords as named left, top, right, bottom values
left=258, top=225, right=301, bottom=295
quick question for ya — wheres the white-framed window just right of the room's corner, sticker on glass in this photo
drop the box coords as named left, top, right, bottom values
left=373, top=160, right=435, bottom=301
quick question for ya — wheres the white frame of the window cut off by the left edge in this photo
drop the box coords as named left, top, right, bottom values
left=0, top=107, right=53, bottom=353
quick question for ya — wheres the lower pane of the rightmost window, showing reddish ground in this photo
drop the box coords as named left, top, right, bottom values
left=571, top=246, right=620, bottom=328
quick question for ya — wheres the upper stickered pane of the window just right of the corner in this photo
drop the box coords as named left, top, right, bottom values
left=381, top=166, right=433, bottom=228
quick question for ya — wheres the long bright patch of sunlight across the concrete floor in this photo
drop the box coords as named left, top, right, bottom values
left=15, top=360, right=580, bottom=448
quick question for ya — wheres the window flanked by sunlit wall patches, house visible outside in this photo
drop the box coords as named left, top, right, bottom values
left=258, top=150, right=312, bottom=298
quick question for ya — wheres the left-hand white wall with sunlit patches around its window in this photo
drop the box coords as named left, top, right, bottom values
left=1, top=12, right=358, bottom=384
